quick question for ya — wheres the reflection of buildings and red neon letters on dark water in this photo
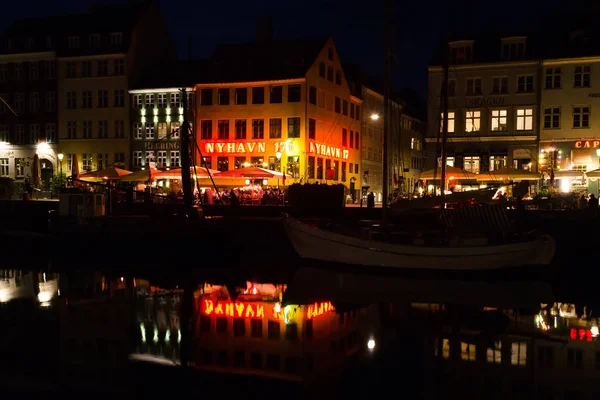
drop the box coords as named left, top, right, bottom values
left=0, top=270, right=600, bottom=399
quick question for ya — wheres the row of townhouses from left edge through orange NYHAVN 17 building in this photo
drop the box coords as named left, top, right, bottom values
left=0, top=6, right=422, bottom=199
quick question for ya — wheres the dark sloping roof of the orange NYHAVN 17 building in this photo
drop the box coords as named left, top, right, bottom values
left=201, top=37, right=329, bottom=83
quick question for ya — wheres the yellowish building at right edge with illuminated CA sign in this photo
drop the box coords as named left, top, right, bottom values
left=539, top=57, right=600, bottom=195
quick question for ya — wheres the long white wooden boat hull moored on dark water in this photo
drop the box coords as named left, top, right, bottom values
left=284, top=218, right=555, bottom=271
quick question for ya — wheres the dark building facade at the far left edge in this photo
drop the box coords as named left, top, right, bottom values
left=0, top=47, right=58, bottom=190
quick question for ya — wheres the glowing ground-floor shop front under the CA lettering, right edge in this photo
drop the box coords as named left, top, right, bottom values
left=539, top=139, right=600, bottom=194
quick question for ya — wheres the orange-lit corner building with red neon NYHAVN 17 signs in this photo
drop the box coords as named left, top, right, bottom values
left=195, top=38, right=361, bottom=193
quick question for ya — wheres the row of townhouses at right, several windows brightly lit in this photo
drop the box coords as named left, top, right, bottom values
left=426, top=31, right=600, bottom=193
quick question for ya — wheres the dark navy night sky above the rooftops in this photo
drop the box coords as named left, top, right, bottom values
left=0, top=0, right=561, bottom=98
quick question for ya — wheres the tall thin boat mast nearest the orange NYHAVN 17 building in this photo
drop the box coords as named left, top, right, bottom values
left=381, top=0, right=393, bottom=228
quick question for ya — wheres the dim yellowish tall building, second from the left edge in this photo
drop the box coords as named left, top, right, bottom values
left=58, top=3, right=172, bottom=173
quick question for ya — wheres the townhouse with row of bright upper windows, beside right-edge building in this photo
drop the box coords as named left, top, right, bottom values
left=426, top=37, right=540, bottom=178
